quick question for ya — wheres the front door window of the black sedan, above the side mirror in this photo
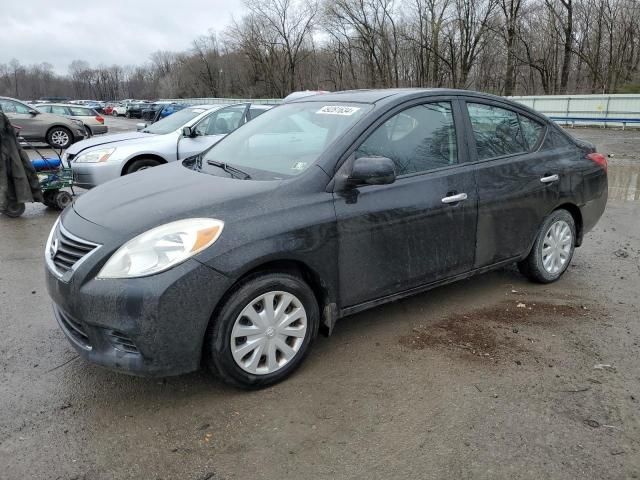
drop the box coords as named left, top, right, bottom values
left=356, top=102, right=458, bottom=175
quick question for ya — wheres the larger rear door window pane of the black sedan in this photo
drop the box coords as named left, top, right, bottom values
left=467, top=103, right=527, bottom=160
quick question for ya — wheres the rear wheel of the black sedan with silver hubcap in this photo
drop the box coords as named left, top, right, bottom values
left=518, top=210, right=576, bottom=283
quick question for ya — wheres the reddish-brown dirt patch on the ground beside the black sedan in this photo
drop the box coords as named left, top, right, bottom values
left=399, top=301, right=596, bottom=359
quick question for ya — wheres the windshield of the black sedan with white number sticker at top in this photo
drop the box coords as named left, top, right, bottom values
left=200, top=102, right=373, bottom=179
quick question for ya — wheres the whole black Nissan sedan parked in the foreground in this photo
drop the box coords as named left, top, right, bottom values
left=45, top=89, right=607, bottom=388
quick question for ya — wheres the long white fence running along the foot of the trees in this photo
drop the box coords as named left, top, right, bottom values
left=161, top=94, right=640, bottom=128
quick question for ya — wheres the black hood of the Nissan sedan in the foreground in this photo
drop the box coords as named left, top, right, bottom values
left=73, top=162, right=281, bottom=236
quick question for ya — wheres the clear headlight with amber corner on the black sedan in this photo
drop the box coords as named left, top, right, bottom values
left=98, top=218, right=224, bottom=278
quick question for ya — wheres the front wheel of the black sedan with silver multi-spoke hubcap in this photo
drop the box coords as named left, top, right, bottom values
left=205, top=273, right=320, bottom=389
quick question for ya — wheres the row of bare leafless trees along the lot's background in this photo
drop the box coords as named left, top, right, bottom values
left=0, top=0, right=640, bottom=100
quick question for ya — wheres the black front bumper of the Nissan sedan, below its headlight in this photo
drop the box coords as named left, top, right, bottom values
left=45, top=214, right=230, bottom=376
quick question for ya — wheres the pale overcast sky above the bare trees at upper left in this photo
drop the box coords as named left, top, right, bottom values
left=0, top=0, right=243, bottom=73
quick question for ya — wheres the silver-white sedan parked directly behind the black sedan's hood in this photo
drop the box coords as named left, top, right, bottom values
left=63, top=103, right=271, bottom=188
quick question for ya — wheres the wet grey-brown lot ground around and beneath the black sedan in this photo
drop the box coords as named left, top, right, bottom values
left=0, top=129, right=640, bottom=480
